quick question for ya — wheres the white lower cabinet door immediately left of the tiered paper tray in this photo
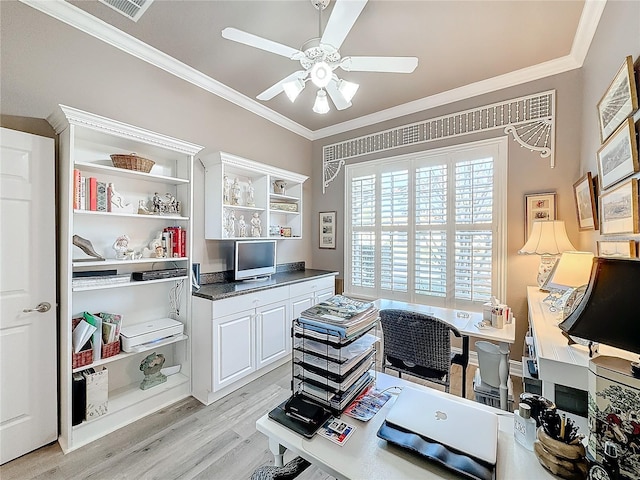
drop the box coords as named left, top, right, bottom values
left=256, top=302, right=291, bottom=368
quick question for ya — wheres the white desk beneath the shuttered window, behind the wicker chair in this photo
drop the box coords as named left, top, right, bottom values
left=374, top=298, right=516, bottom=410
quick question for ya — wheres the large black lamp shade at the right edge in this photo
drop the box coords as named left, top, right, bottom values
left=558, top=257, right=640, bottom=354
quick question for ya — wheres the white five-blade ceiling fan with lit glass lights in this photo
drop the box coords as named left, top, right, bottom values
left=222, top=0, right=418, bottom=113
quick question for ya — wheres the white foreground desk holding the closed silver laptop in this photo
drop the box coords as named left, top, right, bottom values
left=256, top=373, right=556, bottom=480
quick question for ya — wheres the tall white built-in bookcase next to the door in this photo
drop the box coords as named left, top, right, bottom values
left=48, top=105, right=202, bottom=452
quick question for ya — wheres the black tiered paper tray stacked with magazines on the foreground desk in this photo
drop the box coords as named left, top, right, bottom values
left=293, top=295, right=379, bottom=411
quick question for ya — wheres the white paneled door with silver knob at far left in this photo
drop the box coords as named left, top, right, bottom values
left=0, top=128, right=58, bottom=463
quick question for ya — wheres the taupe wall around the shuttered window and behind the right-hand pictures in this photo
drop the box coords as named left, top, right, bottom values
left=312, top=0, right=640, bottom=360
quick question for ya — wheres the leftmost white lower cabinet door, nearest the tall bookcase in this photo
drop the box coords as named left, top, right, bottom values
left=213, top=310, right=256, bottom=391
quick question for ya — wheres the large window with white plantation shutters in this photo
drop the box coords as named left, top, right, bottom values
left=345, top=139, right=507, bottom=310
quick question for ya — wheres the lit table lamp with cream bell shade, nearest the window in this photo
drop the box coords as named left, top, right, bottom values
left=518, top=220, right=575, bottom=287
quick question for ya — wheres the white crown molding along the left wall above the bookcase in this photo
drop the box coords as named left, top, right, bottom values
left=20, top=0, right=312, bottom=140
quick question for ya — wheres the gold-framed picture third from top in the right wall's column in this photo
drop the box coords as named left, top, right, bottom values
left=600, top=178, right=640, bottom=235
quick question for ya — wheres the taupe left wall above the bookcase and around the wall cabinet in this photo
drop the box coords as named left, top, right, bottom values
left=0, top=1, right=312, bottom=272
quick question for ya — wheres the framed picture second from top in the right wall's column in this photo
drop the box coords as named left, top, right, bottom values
left=597, top=118, right=639, bottom=189
